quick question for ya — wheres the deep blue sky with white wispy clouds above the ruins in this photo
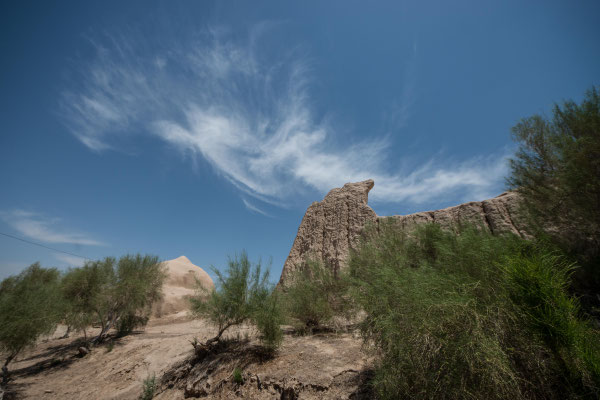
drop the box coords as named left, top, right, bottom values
left=0, top=1, right=600, bottom=281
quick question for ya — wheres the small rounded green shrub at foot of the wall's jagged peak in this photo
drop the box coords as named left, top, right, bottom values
left=284, top=259, right=346, bottom=333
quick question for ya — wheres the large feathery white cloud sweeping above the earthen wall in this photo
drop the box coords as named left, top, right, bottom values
left=62, top=26, right=506, bottom=211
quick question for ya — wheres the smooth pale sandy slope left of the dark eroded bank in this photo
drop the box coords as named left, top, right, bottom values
left=5, top=317, right=206, bottom=399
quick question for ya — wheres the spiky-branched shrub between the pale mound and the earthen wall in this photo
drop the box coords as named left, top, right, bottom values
left=191, top=252, right=281, bottom=348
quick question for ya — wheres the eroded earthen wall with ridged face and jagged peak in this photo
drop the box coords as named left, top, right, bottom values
left=279, top=179, right=527, bottom=287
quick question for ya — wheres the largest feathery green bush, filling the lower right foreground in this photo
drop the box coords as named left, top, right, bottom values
left=350, top=224, right=599, bottom=399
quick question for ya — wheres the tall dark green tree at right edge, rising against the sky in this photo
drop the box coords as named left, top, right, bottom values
left=507, top=87, right=600, bottom=294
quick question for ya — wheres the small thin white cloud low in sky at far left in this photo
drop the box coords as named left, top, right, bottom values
left=0, top=210, right=106, bottom=246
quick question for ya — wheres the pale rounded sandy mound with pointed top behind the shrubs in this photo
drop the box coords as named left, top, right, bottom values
left=152, top=256, right=215, bottom=317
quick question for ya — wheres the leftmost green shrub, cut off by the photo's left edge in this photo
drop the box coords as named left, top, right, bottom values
left=0, top=263, right=62, bottom=384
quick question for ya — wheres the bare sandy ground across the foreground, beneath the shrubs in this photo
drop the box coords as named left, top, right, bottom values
left=3, top=313, right=368, bottom=399
